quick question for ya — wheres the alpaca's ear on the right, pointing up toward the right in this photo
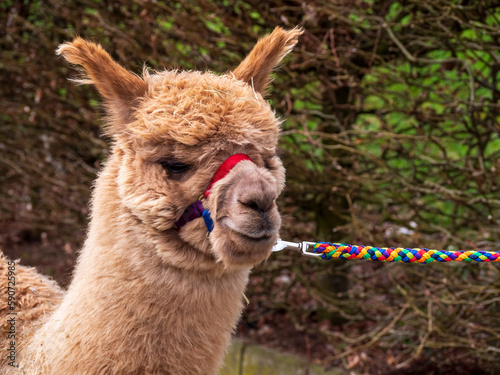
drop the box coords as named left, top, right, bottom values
left=233, top=27, right=304, bottom=94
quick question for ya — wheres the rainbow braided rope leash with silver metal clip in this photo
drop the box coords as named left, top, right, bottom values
left=273, top=239, right=500, bottom=263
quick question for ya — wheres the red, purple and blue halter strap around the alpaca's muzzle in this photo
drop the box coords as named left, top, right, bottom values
left=175, top=154, right=253, bottom=232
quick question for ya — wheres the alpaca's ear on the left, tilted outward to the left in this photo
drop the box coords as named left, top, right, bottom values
left=56, top=38, right=147, bottom=132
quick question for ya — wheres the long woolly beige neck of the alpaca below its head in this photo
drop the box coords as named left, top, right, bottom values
left=23, top=160, right=249, bottom=374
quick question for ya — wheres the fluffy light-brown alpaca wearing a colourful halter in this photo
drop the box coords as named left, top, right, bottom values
left=0, top=27, right=302, bottom=375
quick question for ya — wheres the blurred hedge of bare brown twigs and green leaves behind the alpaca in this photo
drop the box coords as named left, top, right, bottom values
left=0, top=0, right=500, bottom=374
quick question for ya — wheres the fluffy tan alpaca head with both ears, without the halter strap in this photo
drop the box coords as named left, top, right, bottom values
left=58, top=28, right=302, bottom=267
